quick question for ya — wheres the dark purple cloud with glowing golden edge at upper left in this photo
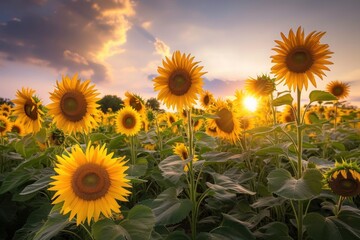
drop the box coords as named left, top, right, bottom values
left=0, top=0, right=135, bottom=82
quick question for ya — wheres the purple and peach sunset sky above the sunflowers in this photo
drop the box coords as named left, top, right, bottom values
left=0, top=0, right=360, bottom=107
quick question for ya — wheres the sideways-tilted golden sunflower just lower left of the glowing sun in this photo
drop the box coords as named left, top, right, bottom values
left=207, top=100, right=240, bottom=142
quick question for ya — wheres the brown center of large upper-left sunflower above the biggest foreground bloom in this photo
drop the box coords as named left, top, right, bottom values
left=60, top=91, right=87, bottom=122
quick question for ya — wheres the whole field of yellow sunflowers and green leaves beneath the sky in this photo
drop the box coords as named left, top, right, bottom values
left=0, top=27, right=360, bottom=240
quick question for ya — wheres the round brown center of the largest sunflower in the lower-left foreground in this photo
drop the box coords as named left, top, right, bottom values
left=71, top=163, right=111, bottom=201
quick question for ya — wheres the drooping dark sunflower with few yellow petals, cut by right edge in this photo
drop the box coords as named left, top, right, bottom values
left=325, top=161, right=360, bottom=197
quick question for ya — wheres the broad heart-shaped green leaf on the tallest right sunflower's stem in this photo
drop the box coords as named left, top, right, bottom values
left=267, top=169, right=322, bottom=200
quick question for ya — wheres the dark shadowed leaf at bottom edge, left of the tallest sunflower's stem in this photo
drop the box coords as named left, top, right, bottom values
left=255, top=222, right=292, bottom=240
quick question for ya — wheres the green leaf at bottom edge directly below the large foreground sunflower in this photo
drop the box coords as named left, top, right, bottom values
left=91, top=219, right=131, bottom=240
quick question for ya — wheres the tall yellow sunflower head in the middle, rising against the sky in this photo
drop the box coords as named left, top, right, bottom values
left=153, top=51, right=205, bottom=110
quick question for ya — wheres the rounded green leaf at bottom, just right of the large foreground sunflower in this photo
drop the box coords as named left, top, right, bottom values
left=120, top=205, right=155, bottom=240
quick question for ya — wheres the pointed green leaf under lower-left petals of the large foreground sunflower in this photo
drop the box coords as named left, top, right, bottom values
left=34, top=204, right=71, bottom=240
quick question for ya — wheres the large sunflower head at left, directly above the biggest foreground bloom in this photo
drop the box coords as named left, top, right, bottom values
left=47, top=74, right=100, bottom=134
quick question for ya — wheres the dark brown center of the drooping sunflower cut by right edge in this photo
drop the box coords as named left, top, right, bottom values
left=329, top=172, right=360, bottom=197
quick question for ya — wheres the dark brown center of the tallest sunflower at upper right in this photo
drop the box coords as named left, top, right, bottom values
left=286, top=47, right=314, bottom=73
